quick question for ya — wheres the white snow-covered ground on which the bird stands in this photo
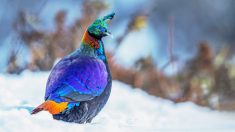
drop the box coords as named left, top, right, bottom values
left=0, top=72, right=235, bottom=132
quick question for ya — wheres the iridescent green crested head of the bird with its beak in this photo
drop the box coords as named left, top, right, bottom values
left=88, top=13, right=115, bottom=39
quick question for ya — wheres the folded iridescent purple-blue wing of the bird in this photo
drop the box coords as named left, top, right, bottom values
left=45, top=56, right=108, bottom=101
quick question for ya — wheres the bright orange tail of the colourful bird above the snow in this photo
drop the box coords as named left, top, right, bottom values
left=31, top=100, right=68, bottom=115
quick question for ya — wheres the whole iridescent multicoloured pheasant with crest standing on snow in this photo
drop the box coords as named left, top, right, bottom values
left=31, top=13, right=115, bottom=124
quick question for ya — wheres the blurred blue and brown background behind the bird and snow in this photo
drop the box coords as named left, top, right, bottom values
left=0, top=0, right=235, bottom=110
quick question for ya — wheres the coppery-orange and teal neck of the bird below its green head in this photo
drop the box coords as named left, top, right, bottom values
left=80, top=31, right=107, bottom=62
